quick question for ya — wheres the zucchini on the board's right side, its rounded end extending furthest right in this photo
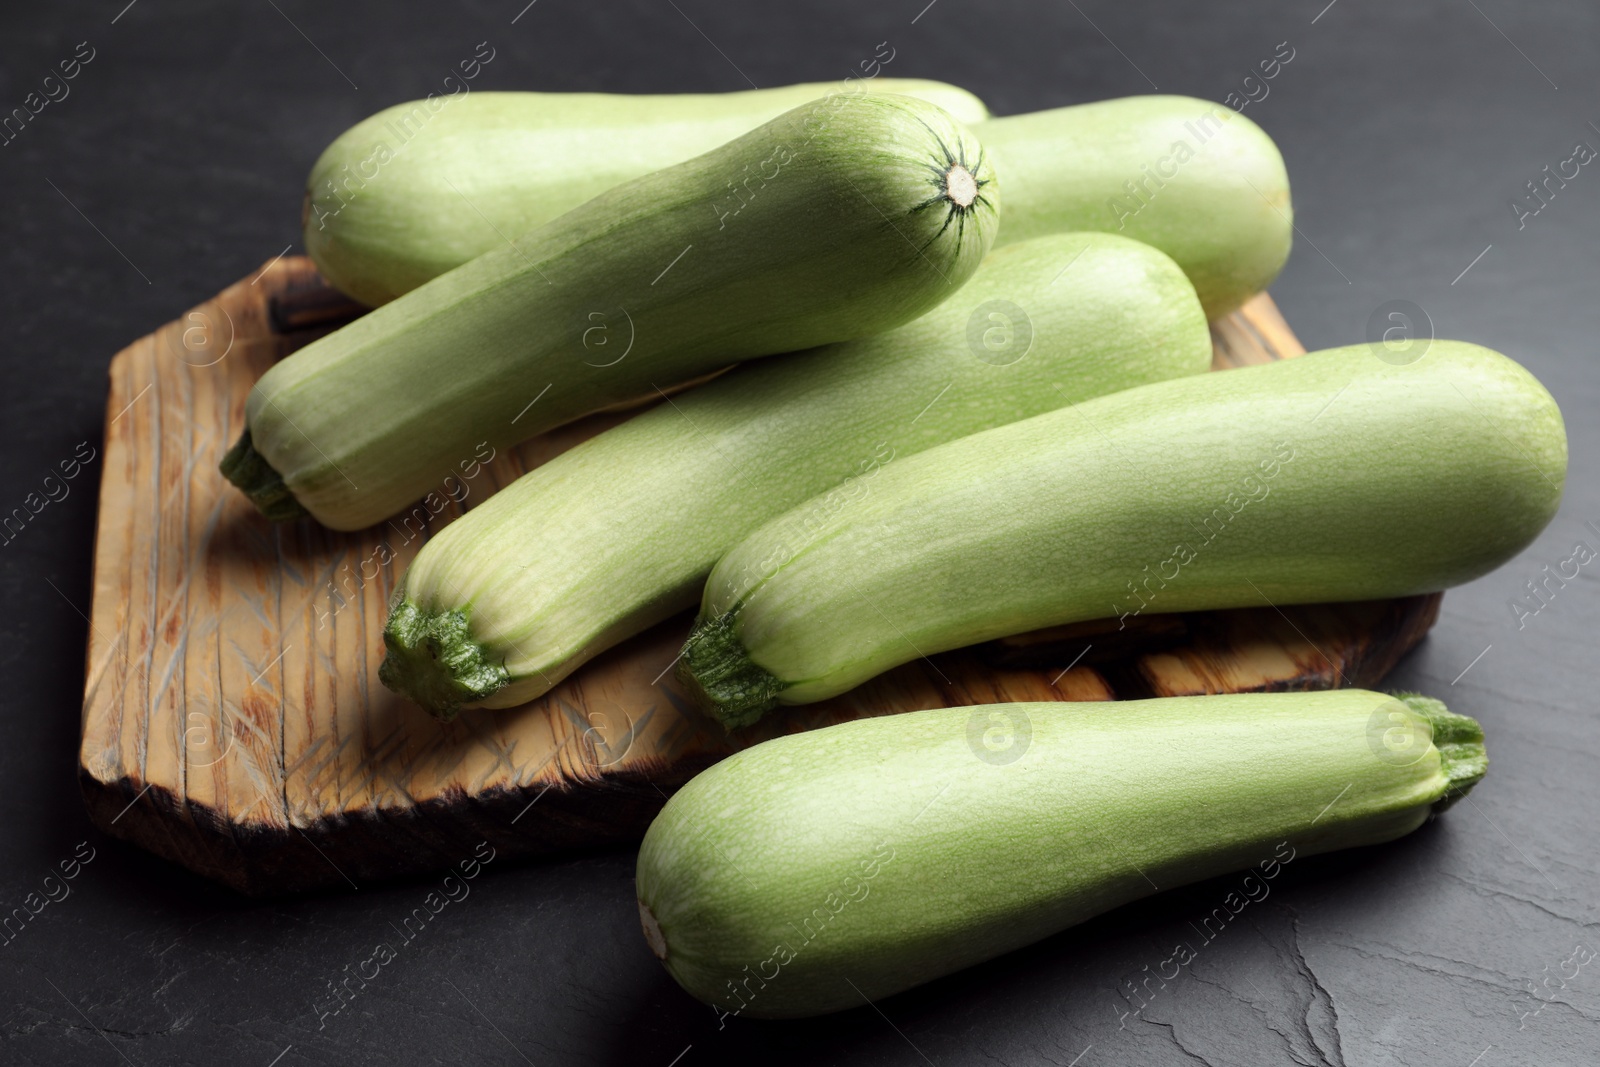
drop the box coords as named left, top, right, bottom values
left=678, top=341, right=1566, bottom=726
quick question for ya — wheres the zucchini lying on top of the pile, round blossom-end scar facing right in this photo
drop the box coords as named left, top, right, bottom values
left=224, top=93, right=998, bottom=530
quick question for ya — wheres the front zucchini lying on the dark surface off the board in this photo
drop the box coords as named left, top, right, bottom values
left=637, top=689, right=1486, bottom=1019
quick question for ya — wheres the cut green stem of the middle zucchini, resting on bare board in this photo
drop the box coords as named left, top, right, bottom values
left=378, top=598, right=510, bottom=723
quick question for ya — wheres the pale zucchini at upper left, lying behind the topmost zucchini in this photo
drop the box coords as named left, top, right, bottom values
left=301, top=77, right=989, bottom=306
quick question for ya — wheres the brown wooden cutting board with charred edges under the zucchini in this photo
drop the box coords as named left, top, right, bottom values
left=78, top=258, right=1438, bottom=893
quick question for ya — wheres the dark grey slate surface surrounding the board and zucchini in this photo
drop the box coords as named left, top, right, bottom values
left=0, top=0, right=1600, bottom=1067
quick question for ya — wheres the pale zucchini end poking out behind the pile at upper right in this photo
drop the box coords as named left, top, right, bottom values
left=976, top=96, right=1294, bottom=320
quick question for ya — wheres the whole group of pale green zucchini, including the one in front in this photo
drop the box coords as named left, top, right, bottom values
left=232, top=78, right=1566, bottom=1017
